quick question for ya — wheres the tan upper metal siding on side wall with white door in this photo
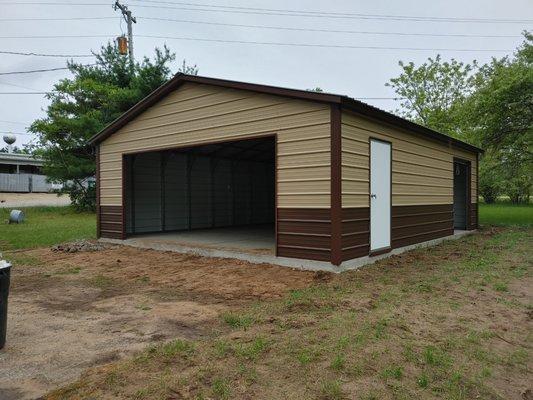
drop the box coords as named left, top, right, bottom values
left=342, top=112, right=477, bottom=207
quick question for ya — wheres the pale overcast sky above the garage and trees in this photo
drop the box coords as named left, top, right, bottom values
left=0, top=0, right=533, bottom=147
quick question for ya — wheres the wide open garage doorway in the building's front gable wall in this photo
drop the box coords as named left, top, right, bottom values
left=124, top=137, right=275, bottom=254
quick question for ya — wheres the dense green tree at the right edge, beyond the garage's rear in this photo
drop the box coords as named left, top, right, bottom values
left=464, top=32, right=533, bottom=203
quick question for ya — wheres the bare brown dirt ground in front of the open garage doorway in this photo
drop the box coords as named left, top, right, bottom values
left=0, top=247, right=318, bottom=400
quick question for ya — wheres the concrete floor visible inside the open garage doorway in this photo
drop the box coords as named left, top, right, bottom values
left=127, top=225, right=276, bottom=255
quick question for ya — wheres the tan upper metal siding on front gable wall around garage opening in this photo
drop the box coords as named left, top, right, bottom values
left=96, top=83, right=330, bottom=208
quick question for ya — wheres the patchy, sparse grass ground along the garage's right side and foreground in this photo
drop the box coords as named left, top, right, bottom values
left=46, top=228, right=533, bottom=400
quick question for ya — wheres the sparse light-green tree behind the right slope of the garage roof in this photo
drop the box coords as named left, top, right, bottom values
left=385, top=55, right=477, bottom=139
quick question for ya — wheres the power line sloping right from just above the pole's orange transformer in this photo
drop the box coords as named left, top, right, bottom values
left=137, top=35, right=511, bottom=53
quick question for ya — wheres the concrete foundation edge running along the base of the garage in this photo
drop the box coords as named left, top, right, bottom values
left=99, top=230, right=476, bottom=273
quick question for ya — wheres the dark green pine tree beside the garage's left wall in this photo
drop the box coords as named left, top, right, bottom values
left=30, top=43, right=198, bottom=209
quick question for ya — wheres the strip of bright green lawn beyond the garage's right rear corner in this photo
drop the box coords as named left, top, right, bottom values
left=479, top=203, right=533, bottom=226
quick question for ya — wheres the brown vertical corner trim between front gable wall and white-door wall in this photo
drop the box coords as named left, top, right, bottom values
left=330, top=104, right=342, bottom=265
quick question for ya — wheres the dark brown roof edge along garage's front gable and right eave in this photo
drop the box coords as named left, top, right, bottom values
left=89, top=73, right=483, bottom=153
